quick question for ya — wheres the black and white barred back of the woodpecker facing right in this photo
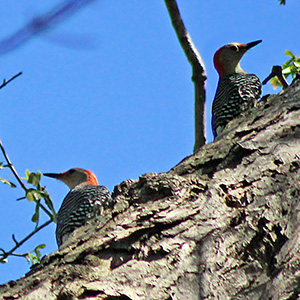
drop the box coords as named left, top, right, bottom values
left=212, top=73, right=261, bottom=138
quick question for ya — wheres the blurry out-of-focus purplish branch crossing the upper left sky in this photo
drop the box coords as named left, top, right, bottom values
left=0, top=0, right=96, bottom=55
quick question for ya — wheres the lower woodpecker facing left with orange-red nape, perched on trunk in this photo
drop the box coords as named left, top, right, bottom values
left=44, top=168, right=112, bottom=247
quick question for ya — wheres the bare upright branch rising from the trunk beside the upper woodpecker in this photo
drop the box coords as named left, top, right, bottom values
left=165, top=0, right=206, bottom=153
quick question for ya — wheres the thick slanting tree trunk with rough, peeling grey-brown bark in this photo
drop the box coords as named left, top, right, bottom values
left=0, top=82, right=300, bottom=300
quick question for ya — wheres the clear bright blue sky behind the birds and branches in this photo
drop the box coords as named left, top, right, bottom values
left=0, top=0, right=300, bottom=283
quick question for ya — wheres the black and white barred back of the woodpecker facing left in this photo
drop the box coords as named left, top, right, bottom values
left=56, top=185, right=113, bottom=247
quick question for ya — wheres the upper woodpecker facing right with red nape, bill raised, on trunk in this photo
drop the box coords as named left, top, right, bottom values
left=212, top=40, right=261, bottom=138
